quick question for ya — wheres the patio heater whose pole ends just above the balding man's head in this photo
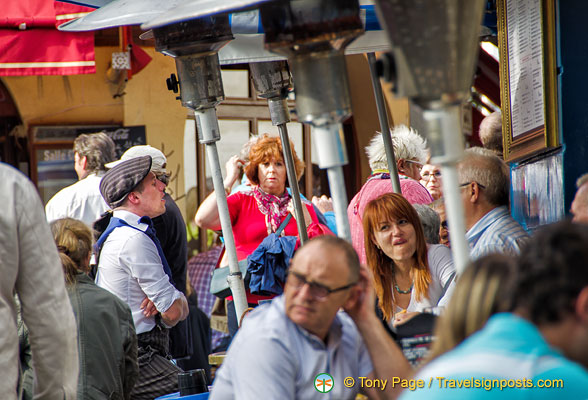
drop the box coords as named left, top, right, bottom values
left=260, top=0, right=364, bottom=240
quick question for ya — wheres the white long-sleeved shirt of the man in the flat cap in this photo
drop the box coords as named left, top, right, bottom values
left=96, top=210, right=182, bottom=334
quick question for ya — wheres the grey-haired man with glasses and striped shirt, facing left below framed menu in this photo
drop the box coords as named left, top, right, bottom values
left=457, top=148, right=529, bottom=260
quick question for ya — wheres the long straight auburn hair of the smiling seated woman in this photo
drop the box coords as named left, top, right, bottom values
left=363, top=193, right=431, bottom=321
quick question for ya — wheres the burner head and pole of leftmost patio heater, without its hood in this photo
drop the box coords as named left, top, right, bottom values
left=153, top=15, right=248, bottom=320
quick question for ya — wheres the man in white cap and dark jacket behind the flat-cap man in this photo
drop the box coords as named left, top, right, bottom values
left=102, top=145, right=192, bottom=358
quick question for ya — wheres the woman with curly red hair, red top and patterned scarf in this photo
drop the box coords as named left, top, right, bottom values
left=195, top=134, right=331, bottom=331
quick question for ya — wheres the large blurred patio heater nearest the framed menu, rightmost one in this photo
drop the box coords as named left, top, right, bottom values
left=376, top=0, right=485, bottom=274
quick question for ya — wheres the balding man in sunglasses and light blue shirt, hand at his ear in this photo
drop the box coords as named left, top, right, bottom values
left=211, top=235, right=410, bottom=400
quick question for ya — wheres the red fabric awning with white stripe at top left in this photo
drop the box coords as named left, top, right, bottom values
left=0, top=0, right=96, bottom=76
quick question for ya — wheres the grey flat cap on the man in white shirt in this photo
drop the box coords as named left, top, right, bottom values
left=100, top=156, right=152, bottom=209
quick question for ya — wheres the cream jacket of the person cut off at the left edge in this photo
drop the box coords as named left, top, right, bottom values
left=0, top=163, right=78, bottom=400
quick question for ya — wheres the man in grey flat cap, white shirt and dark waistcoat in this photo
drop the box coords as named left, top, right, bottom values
left=96, top=156, right=188, bottom=399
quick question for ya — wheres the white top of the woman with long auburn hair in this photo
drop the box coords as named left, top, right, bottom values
left=396, top=244, right=455, bottom=314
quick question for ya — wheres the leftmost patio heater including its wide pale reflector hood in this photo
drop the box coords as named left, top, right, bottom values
left=59, top=0, right=278, bottom=319
